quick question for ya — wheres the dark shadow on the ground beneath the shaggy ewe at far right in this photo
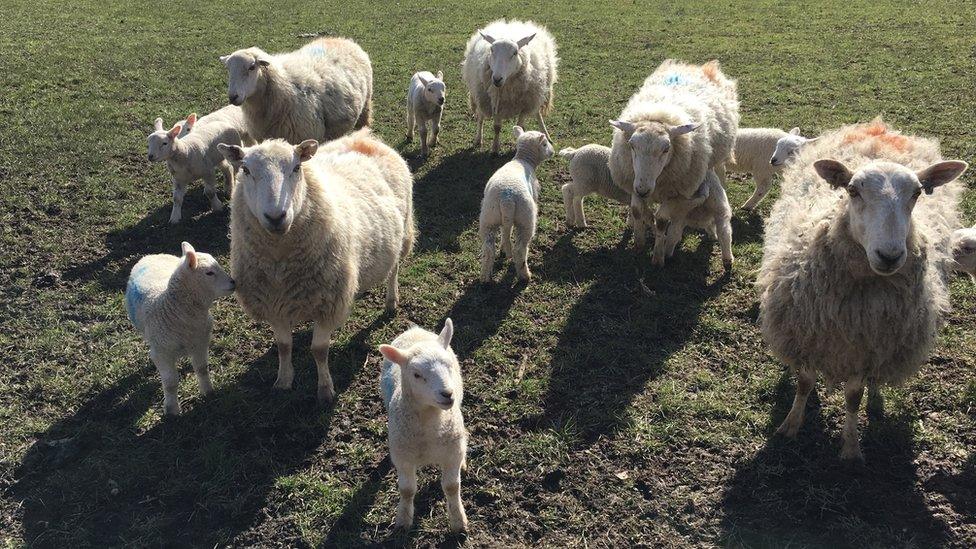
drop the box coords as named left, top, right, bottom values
left=722, top=372, right=952, bottom=547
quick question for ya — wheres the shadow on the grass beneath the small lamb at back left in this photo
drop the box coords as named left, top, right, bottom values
left=63, top=197, right=230, bottom=291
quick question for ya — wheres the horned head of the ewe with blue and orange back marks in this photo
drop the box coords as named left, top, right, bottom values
left=610, top=120, right=700, bottom=199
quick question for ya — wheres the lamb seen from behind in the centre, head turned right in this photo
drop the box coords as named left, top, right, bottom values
left=478, top=126, right=554, bottom=282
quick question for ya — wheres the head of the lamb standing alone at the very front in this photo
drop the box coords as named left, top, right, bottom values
left=380, top=318, right=462, bottom=410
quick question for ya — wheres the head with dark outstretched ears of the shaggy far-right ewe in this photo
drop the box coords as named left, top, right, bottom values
left=813, top=160, right=968, bottom=275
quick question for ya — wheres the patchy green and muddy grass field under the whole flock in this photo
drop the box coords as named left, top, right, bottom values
left=0, top=0, right=976, bottom=547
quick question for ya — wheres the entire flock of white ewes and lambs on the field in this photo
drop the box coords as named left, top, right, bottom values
left=126, top=20, right=976, bottom=531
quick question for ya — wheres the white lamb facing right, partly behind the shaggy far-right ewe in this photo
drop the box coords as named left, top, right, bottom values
left=718, top=128, right=817, bottom=211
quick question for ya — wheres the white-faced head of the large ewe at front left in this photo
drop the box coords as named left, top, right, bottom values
left=217, top=139, right=319, bottom=234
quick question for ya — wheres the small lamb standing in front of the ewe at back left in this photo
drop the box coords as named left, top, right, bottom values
left=148, top=106, right=244, bottom=224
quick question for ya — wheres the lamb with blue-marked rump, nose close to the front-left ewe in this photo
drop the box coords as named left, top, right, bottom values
left=125, top=242, right=235, bottom=415
